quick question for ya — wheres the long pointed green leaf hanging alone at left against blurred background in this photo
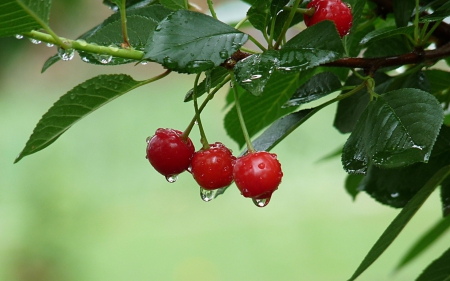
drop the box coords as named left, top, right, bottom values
left=14, top=74, right=145, bottom=163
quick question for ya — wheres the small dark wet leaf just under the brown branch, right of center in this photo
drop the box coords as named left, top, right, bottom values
left=285, top=72, right=342, bottom=106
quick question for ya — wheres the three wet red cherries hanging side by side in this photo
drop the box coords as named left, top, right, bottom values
left=147, top=128, right=283, bottom=207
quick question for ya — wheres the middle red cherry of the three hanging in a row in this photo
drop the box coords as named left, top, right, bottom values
left=191, top=142, right=236, bottom=190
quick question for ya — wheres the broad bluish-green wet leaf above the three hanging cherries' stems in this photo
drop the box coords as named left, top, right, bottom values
left=144, top=10, right=248, bottom=73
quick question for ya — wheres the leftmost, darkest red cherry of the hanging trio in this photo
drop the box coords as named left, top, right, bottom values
left=147, top=128, right=195, bottom=181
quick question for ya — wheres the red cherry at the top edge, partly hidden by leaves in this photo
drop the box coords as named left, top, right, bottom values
left=303, top=0, right=353, bottom=37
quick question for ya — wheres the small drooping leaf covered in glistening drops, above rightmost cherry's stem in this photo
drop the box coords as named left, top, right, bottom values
left=234, top=51, right=280, bottom=96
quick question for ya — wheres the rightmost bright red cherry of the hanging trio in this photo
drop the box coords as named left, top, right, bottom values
left=233, top=151, right=283, bottom=200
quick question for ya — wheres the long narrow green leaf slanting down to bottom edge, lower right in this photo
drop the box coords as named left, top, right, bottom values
left=349, top=165, right=450, bottom=281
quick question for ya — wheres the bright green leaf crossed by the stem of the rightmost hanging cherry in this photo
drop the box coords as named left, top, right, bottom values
left=224, top=72, right=299, bottom=149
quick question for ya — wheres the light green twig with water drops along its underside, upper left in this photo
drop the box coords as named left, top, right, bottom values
left=22, top=31, right=144, bottom=60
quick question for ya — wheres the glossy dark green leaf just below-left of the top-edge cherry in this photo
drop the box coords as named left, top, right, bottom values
left=278, top=20, right=345, bottom=72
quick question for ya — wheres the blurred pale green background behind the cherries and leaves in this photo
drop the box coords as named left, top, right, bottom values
left=0, top=0, right=450, bottom=281
